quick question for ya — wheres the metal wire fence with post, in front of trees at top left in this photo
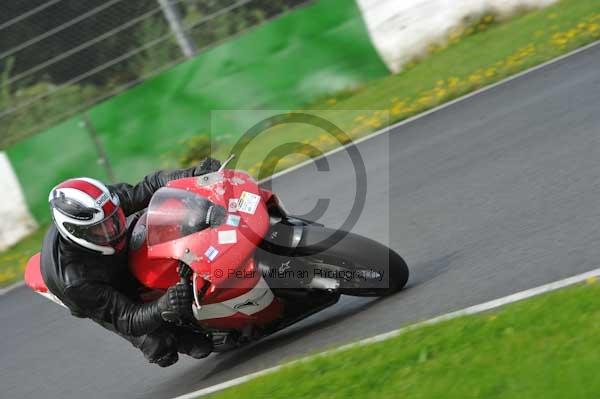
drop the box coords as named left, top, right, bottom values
left=0, top=0, right=310, bottom=148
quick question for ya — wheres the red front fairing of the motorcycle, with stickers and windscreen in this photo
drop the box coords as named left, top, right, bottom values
left=129, top=170, right=282, bottom=328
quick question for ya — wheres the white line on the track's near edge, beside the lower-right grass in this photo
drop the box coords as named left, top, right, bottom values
left=173, top=269, right=600, bottom=399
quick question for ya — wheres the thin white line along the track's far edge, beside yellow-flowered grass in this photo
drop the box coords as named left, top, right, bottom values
left=259, top=40, right=600, bottom=184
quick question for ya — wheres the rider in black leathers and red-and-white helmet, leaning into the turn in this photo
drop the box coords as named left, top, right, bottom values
left=41, top=158, right=220, bottom=367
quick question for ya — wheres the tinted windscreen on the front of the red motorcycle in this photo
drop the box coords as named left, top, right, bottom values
left=147, top=187, right=221, bottom=246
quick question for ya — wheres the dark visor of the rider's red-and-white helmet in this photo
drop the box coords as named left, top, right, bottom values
left=64, top=207, right=126, bottom=246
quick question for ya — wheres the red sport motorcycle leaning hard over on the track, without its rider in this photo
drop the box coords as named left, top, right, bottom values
left=25, top=157, right=409, bottom=352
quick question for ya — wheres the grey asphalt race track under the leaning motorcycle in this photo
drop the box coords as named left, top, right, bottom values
left=0, top=42, right=600, bottom=399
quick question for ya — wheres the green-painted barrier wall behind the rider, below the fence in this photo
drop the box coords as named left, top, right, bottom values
left=8, top=0, right=388, bottom=221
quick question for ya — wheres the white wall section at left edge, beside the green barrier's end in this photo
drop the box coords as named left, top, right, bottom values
left=0, top=152, right=37, bottom=250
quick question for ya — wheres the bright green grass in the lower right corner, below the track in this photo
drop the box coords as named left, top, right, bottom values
left=210, top=281, right=600, bottom=399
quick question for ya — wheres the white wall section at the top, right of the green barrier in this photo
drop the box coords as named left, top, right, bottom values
left=357, top=0, right=557, bottom=72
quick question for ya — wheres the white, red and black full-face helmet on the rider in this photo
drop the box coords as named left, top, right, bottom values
left=48, top=177, right=127, bottom=255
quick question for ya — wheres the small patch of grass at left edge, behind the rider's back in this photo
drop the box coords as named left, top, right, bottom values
left=0, top=227, right=46, bottom=287
